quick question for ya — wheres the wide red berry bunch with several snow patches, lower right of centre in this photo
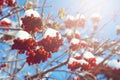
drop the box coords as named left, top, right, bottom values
left=68, top=53, right=96, bottom=71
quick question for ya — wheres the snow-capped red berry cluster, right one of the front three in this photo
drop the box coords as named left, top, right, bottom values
left=38, top=28, right=63, bottom=53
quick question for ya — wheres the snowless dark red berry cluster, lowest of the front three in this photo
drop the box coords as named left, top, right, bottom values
left=26, top=47, right=51, bottom=65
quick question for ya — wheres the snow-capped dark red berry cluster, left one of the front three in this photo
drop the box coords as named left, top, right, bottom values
left=12, top=30, right=37, bottom=53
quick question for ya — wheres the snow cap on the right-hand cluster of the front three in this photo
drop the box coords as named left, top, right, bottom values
left=43, top=28, right=61, bottom=39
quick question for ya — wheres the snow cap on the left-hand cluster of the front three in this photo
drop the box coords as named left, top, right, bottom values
left=15, top=30, right=32, bottom=39
